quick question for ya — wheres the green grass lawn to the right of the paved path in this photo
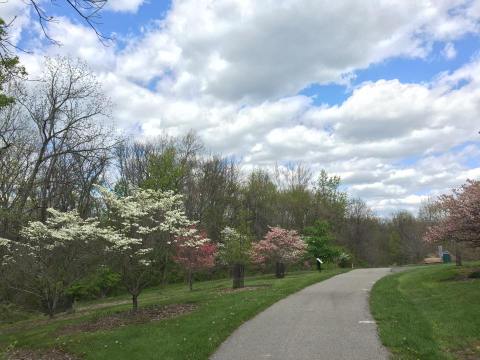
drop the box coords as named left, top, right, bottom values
left=370, top=262, right=480, bottom=360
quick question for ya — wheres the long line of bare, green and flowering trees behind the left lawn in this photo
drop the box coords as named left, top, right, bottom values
left=0, top=51, right=476, bottom=314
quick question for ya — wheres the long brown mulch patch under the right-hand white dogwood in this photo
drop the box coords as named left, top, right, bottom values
left=60, top=304, right=197, bottom=335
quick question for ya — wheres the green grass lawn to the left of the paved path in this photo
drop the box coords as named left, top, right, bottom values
left=0, top=269, right=344, bottom=360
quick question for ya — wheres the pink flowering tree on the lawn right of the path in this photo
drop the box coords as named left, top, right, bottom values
left=425, top=180, right=480, bottom=265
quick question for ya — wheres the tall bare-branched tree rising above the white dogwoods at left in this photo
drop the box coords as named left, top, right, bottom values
left=15, top=58, right=116, bottom=220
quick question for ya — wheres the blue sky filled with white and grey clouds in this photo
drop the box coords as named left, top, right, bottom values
left=0, top=0, right=480, bottom=215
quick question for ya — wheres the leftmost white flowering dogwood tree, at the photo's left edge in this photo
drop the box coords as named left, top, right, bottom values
left=0, top=209, right=99, bottom=317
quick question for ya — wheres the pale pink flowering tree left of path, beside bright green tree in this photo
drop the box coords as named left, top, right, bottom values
left=252, top=227, right=306, bottom=278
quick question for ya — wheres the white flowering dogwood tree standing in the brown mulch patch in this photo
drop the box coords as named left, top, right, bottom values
left=98, top=187, right=194, bottom=311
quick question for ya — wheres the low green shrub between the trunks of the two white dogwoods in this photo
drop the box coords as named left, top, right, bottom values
left=66, top=266, right=121, bottom=300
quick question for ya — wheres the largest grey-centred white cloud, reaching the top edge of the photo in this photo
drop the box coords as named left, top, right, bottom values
left=118, top=0, right=478, bottom=101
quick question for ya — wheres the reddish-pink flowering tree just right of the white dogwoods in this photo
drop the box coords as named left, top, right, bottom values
left=173, top=226, right=217, bottom=290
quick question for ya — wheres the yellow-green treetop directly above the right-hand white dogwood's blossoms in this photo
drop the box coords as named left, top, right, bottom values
left=142, top=146, right=186, bottom=192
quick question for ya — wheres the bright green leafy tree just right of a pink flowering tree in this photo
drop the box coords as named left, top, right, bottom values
left=304, top=220, right=341, bottom=271
